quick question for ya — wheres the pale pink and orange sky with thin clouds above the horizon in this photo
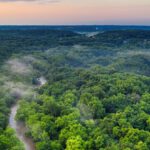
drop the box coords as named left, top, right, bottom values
left=0, top=0, right=150, bottom=25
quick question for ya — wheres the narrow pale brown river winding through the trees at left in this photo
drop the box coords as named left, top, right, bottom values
left=9, top=77, right=46, bottom=150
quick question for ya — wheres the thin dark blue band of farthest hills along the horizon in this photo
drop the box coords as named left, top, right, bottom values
left=0, top=25, right=150, bottom=32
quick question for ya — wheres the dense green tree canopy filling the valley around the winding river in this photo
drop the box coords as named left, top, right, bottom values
left=0, top=30, right=150, bottom=150
